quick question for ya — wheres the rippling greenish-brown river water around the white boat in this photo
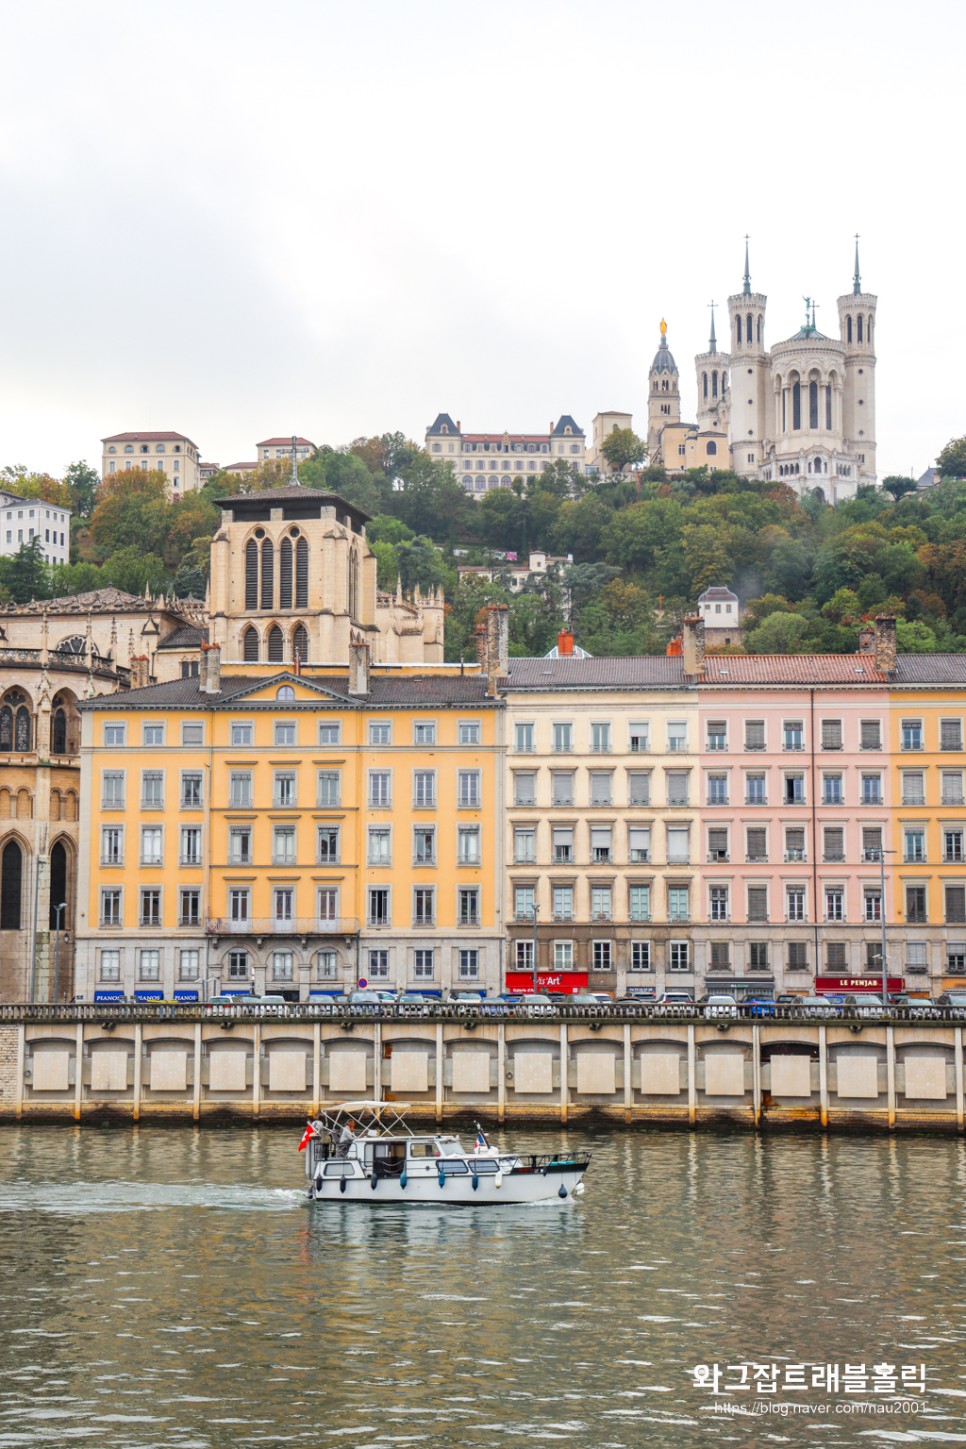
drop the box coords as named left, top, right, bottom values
left=0, top=1127, right=966, bottom=1449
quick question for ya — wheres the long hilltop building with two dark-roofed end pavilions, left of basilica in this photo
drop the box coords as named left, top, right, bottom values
left=426, top=413, right=587, bottom=494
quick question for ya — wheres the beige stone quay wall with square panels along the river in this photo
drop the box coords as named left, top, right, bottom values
left=0, top=1006, right=966, bottom=1132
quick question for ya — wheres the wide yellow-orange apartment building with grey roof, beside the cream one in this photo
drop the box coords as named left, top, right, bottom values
left=75, top=642, right=503, bottom=1000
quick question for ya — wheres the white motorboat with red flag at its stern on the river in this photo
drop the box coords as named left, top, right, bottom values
left=300, top=1101, right=591, bottom=1207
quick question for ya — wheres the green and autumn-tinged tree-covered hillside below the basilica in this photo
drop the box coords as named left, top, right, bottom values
left=0, top=433, right=966, bottom=659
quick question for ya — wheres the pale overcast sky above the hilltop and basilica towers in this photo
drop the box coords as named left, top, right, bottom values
left=0, top=0, right=966, bottom=475
